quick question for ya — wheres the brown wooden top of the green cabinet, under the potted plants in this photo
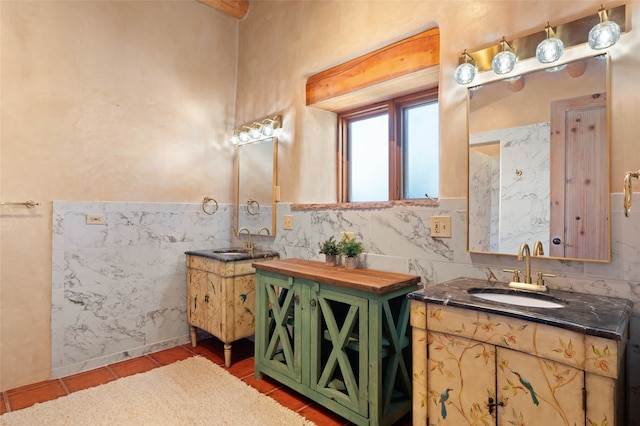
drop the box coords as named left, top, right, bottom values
left=253, top=259, right=420, bottom=294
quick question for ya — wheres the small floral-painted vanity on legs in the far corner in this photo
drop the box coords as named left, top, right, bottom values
left=186, top=249, right=278, bottom=367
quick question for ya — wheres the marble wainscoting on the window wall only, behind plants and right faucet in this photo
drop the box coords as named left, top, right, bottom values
left=264, top=197, right=640, bottom=426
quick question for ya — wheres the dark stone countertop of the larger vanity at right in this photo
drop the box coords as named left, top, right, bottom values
left=408, top=278, right=633, bottom=340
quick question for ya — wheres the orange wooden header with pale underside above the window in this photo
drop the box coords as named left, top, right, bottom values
left=306, top=28, right=440, bottom=112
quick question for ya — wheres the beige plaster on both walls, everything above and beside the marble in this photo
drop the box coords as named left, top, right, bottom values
left=0, top=0, right=640, bottom=389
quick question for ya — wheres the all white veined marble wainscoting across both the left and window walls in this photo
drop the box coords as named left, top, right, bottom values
left=52, top=193, right=640, bottom=424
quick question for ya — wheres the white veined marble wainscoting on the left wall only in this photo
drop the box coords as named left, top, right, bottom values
left=51, top=201, right=235, bottom=378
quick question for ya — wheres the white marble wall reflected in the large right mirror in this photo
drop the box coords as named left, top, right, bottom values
left=470, top=122, right=550, bottom=253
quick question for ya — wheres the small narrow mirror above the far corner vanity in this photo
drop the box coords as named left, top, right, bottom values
left=236, top=137, right=278, bottom=236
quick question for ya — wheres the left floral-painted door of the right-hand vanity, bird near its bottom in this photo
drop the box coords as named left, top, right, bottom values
left=427, top=331, right=498, bottom=425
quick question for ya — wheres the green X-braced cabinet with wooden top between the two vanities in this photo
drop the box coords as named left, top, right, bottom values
left=254, top=259, right=420, bottom=425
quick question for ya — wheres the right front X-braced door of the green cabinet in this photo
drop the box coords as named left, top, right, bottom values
left=309, top=284, right=370, bottom=416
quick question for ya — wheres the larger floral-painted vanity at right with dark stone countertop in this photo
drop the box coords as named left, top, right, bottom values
left=409, top=278, right=633, bottom=426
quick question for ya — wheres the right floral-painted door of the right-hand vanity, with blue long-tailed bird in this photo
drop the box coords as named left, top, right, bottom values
left=497, top=347, right=585, bottom=426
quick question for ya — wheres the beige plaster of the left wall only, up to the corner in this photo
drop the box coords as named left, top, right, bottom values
left=0, top=0, right=238, bottom=390
